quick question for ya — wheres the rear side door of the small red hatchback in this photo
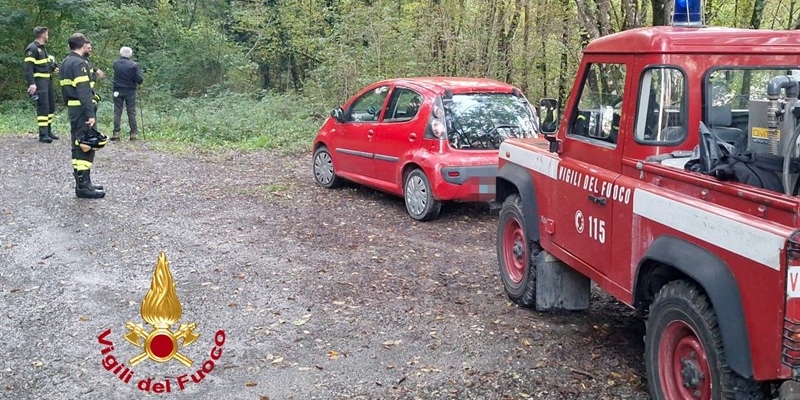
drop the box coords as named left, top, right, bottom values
left=372, top=86, right=427, bottom=187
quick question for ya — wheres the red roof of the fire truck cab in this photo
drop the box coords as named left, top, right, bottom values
left=584, top=26, right=800, bottom=54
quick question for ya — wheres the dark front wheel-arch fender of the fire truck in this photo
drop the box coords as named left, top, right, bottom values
left=495, top=163, right=539, bottom=241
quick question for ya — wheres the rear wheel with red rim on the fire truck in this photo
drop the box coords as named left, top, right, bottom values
left=645, top=281, right=766, bottom=400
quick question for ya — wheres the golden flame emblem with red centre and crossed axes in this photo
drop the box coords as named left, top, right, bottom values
left=123, top=251, right=200, bottom=367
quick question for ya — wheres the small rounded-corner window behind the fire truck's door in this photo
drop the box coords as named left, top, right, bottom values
left=635, top=67, right=687, bottom=145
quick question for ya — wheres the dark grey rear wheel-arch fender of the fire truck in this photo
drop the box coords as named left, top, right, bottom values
left=634, top=235, right=753, bottom=378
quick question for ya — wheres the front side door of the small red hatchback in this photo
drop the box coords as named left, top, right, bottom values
left=333, top=84, right=390, bottom=178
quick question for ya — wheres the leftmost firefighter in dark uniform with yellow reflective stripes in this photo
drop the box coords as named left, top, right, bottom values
left=24, top=26, right=58, bottom=143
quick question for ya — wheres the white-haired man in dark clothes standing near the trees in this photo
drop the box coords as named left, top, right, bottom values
left=111, top=46, right=144, bottom=140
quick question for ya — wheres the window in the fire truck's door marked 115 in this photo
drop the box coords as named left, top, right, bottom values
left=569, top=63, right=625, bottom=144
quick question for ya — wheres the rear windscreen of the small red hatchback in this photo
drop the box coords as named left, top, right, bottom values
left=444, top=93, right=538, bottom=150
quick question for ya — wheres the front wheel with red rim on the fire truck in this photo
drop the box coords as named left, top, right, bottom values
left=497, top=194, right=541, bottom=307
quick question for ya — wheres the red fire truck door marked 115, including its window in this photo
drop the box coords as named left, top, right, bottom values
left=553, top=60, right=630, bottom=276
